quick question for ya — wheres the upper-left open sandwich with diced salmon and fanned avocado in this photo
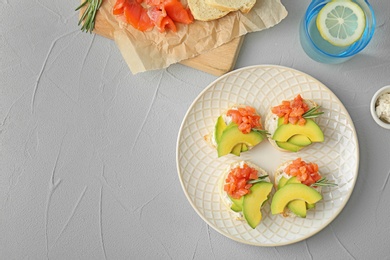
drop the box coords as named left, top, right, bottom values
left=204, top=105, right=266, bottom=157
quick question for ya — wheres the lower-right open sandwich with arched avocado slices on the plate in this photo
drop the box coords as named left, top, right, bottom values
left=271, top=158, right=336, bottom=218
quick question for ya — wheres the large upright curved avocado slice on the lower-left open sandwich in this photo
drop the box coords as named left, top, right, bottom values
left=242, top=182, right=273, bottom=229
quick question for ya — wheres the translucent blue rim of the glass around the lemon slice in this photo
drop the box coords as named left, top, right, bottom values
left=303, top=0, right=376, bottom=58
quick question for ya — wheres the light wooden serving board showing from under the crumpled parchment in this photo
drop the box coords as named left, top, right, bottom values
left=89, top=1, right=244, bottom=76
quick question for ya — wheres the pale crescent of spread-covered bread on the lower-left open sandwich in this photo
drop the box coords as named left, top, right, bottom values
left=218, top=161, right=271, bottom=220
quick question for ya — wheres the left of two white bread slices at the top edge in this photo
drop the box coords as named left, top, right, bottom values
left=187, top=0, right=229, bottom=22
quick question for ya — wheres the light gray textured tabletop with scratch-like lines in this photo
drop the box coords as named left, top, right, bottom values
left=0, top=0, right=390, bottom=259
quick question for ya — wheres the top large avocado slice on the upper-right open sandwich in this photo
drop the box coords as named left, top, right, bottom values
left=272, top=118, right=324, bottom=142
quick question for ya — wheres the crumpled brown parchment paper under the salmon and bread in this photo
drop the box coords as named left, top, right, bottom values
left=99, top=0, right=287, bottom=74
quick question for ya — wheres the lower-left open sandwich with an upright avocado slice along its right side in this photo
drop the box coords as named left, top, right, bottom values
left=219, top=161, right=273, bottom=228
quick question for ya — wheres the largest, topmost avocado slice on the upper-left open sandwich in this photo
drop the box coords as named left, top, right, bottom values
left=217, top=123, right=264, bottom=157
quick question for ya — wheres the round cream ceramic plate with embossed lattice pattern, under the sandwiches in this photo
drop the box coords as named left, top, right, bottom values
left=176, top=65, right=359, bottom=246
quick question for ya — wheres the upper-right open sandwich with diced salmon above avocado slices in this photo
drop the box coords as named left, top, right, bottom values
left=265, top=95, right=324, bottom=152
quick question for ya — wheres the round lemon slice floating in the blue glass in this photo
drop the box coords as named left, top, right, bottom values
left=316, top=0, right=366, bottom=46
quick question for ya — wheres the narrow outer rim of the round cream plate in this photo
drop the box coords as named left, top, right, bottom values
left=176, top=65, right=359, bottom=247
